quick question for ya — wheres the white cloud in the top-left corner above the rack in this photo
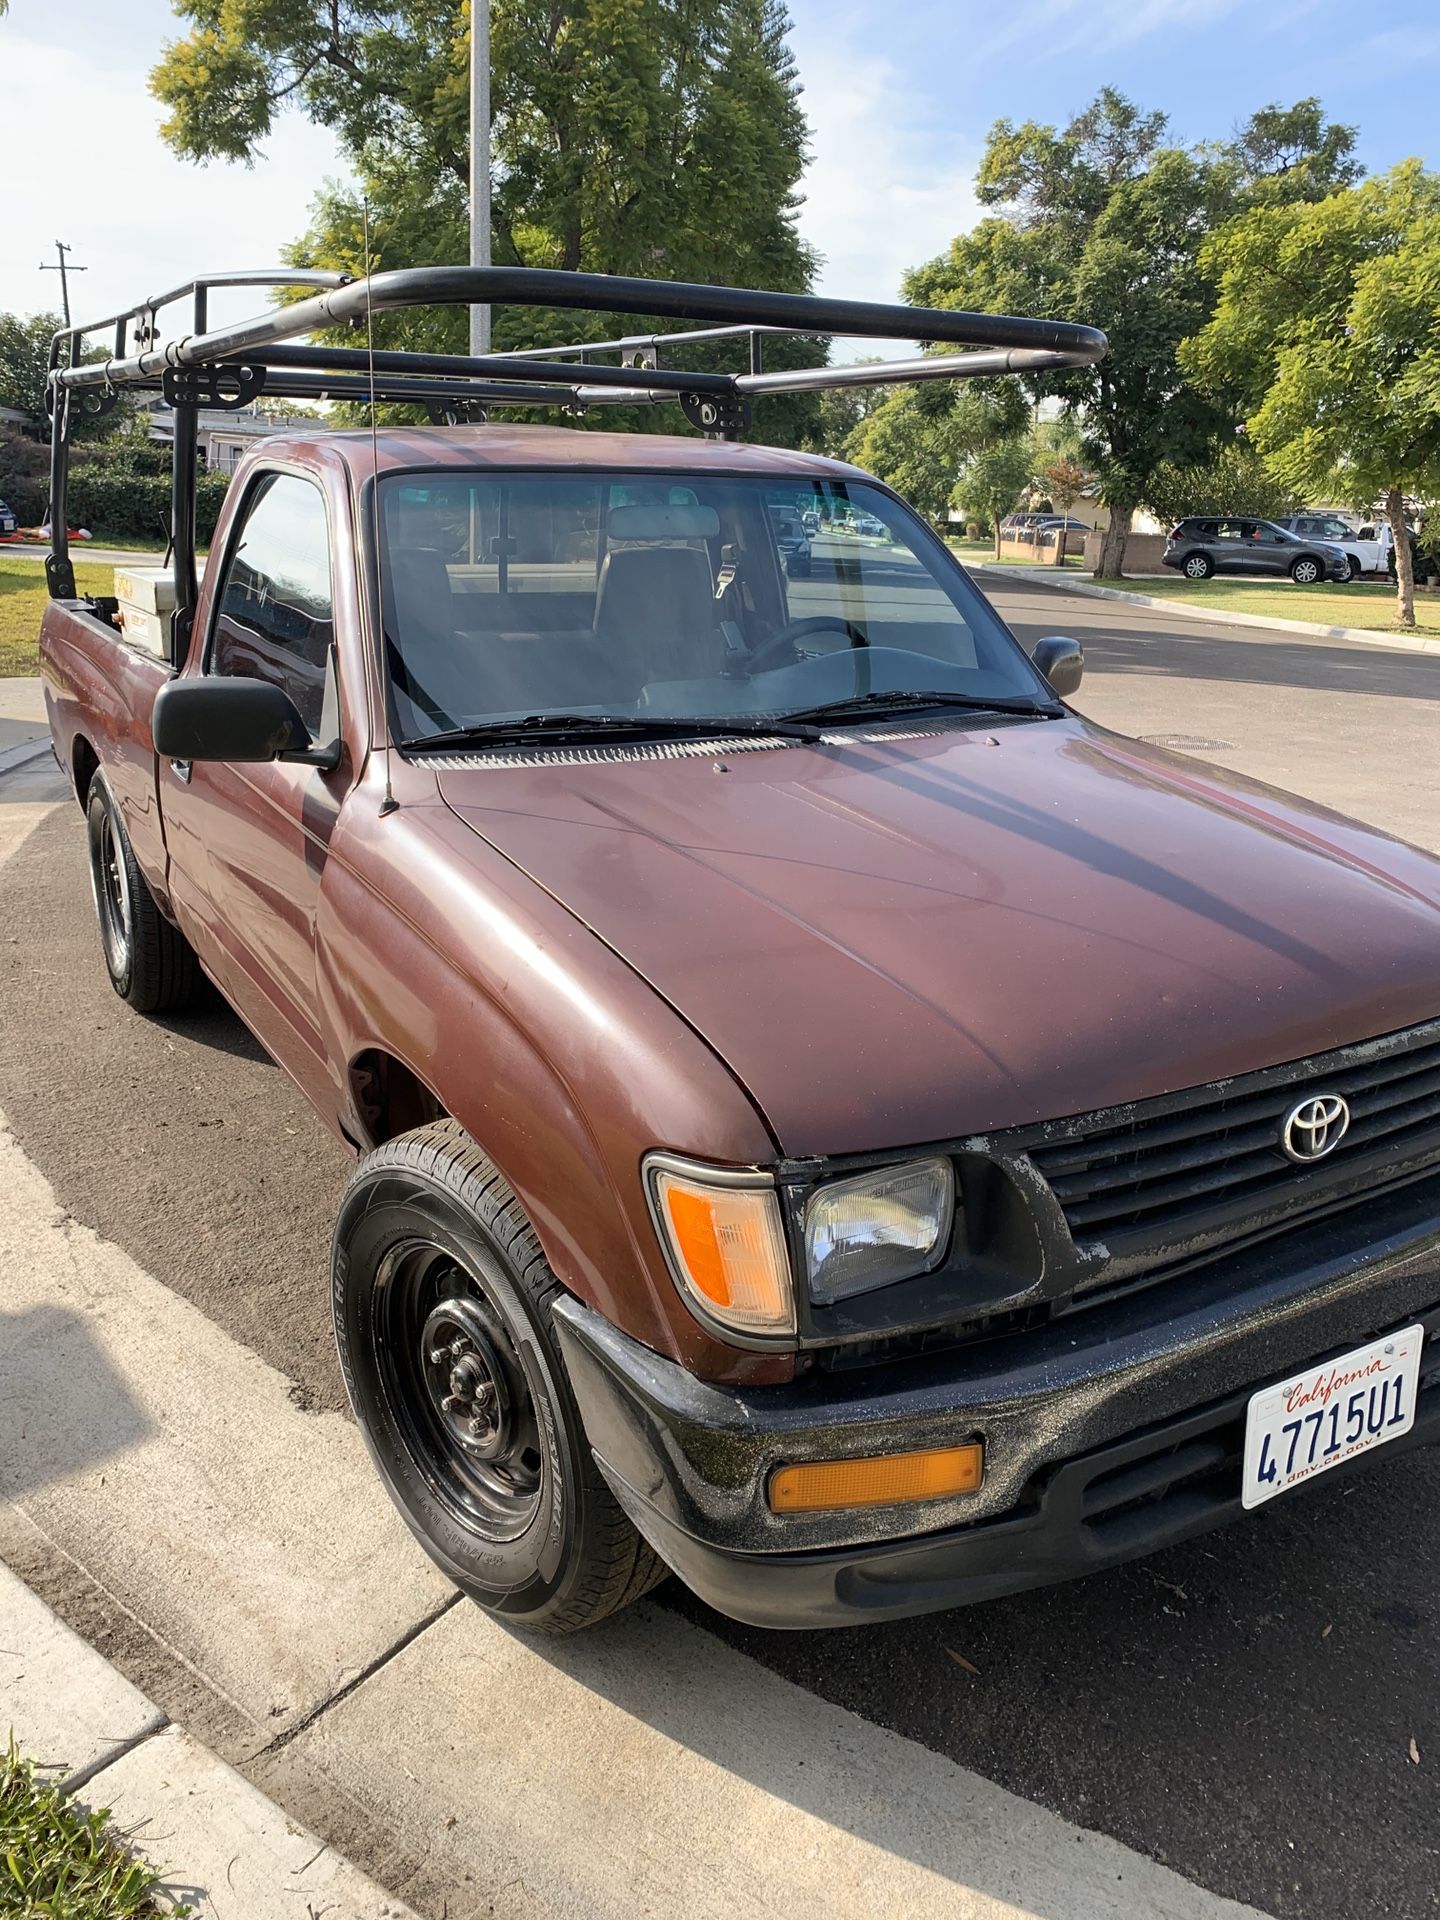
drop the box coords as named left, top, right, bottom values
left=0, top=6, right=344, bottom=339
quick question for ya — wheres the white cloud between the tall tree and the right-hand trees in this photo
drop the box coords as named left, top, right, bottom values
left=795, top=12, right=979, bottom=334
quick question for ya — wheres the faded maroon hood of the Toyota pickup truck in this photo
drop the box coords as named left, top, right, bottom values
left=440, top=718, right=1440, bottom=1156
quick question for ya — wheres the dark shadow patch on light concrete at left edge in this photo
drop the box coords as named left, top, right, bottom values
left=0, top=1306, right=154, bottom=1500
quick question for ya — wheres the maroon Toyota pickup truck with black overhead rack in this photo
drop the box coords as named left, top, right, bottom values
left=42, top=271, right=1440, bottom=1632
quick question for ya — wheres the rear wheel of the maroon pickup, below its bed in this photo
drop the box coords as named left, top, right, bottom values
left=84, top=774, right=205, bottom=1014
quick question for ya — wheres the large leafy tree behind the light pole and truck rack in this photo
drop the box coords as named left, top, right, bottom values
left=152, top=0, right=816, bottom=430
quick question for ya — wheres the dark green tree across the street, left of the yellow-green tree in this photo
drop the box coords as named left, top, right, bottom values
left=906, top=88, right=1354, bottom=578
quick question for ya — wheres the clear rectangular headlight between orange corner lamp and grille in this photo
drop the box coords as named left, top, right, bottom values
left=804, top=1160, right=954, bottom=1304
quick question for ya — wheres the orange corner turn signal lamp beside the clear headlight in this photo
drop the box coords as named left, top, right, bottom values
left=645, top=1154, right=795, bottom=1336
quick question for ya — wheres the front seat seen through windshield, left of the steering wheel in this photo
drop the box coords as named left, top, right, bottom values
left=595, top=547, right=724, bottom=693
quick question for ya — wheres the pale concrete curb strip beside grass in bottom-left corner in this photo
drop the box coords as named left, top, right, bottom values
left=0, top=1565, right=417, bottom=1920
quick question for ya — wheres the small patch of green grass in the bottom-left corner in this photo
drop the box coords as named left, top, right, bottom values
left=0, top=1740, right=194, bottom=1920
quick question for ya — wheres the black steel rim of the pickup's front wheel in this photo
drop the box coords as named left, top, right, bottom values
left=374, top=1240, right=545, bottom=1542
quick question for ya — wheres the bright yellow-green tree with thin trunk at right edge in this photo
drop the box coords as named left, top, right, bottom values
left=1181, top=159, right=1440, bottom=626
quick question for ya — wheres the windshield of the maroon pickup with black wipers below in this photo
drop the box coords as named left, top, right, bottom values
left=380, top=470, right=1050, bottom=745
